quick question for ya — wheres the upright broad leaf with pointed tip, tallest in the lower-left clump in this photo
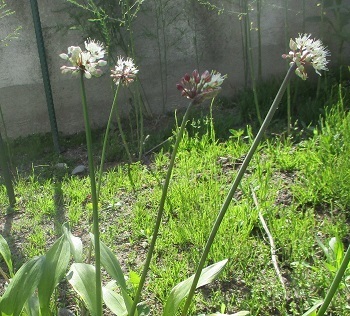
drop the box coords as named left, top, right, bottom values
left=38, top=235, right=70, bottom=315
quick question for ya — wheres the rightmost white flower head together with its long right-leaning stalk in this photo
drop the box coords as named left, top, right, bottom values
left=181, top=35, right=329, bottom=316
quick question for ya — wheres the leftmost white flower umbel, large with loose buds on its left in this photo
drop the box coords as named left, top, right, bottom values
left=60, top=39, right=107, bottom=79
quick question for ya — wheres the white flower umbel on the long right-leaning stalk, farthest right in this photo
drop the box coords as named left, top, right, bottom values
left=282, top=34, right=330, bottom=80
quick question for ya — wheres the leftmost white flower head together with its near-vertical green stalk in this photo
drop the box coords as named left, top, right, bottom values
left=60, top=39, right=107, bottom=316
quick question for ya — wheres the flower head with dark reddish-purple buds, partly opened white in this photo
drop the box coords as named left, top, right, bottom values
left=176, top=70, right=226, bottom=104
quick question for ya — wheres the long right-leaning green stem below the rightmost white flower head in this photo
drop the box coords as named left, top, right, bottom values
left=181, top=64, right=295, bottom=316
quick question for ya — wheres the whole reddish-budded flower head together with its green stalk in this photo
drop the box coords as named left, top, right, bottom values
left=129, top=70, right=226, bottom=316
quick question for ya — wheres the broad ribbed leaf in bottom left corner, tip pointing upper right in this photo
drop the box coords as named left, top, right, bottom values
left=0, top=256, right=45, bottom=316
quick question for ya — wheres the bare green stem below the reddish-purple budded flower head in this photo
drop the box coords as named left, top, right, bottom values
left=130, top=102, right=193, bottom=316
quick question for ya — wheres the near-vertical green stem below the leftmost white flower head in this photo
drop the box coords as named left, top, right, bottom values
left=80, top=72, right=102, bottom=316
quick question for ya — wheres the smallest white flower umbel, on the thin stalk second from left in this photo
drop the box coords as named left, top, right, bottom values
left=111, top=56, right=139, bottom=86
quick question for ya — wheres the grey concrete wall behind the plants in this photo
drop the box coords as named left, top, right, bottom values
left=0, top=0, right=350, bottom=137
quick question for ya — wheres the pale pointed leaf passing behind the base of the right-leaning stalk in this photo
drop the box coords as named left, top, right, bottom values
left=163, top=259, right=227, bottom=316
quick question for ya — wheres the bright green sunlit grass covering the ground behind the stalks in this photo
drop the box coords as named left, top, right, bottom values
left=0, top=85, right=350, bottom=316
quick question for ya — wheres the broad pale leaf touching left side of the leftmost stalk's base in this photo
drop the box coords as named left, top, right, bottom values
left=67, top=263, right=98, bottom=316
